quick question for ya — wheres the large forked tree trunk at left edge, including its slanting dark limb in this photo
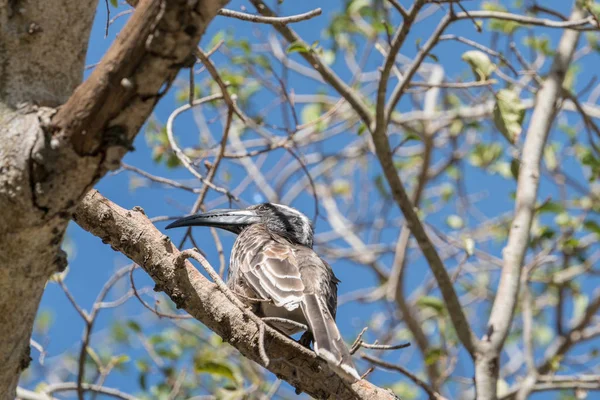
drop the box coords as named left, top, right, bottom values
left=0, top=0, right=227, bottom=399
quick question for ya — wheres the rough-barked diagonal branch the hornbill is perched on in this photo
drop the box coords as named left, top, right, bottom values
left=74, top=190, right=396, bottom=400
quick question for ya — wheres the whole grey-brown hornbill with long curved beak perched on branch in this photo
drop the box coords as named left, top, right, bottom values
left=166, top=203, right=360, bottom=383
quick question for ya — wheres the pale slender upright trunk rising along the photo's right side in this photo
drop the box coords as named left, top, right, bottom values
left=475, top=3, right=585, bottom=399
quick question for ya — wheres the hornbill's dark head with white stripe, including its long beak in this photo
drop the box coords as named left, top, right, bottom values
left=166, top=203, right=314, bottom=247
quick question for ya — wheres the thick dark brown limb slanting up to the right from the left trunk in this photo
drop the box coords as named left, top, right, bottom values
left=51, top=0, right=228, bottom=162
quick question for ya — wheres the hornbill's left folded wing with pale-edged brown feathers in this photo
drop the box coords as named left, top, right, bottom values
left=241, top=239, right=304, bottom=311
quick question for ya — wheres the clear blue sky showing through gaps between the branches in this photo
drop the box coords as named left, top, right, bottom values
left=19, top=0, right=598, bottom=398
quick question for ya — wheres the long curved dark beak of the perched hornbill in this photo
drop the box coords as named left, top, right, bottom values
left=165, top=209, right=260, bottom=230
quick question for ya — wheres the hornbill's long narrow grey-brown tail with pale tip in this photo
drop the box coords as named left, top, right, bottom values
left=302, top=294, right=360, bottom=382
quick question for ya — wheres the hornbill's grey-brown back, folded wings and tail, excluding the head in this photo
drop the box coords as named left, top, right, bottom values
left=238, top=227, right=360, bottom=382
